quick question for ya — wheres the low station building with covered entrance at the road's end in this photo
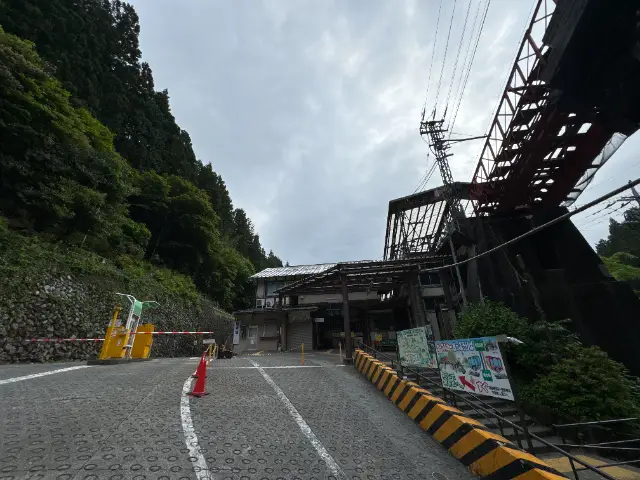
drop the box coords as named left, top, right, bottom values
left=234, top=255, right=456, bottom=353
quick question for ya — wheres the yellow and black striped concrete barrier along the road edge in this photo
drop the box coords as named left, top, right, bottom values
left=354, top=349, right=566, bottom=480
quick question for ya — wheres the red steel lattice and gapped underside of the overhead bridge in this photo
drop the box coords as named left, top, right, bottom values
left=471, top=0, right=622, bottom=215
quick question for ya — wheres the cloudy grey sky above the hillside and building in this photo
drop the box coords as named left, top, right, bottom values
left=132, top=0, right=640, bottom=264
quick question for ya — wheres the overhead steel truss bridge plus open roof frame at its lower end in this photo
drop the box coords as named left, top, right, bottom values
left=384, top=0, right=640, bottom=260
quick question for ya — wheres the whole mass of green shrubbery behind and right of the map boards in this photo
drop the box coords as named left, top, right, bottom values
left=454, top=301, right=640, bottom=422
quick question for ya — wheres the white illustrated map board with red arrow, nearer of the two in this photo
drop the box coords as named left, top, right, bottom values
left=435, top=337, right=513, bottom=400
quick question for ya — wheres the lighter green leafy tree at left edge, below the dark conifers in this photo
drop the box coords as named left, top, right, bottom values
left=0, top=25, right=144, bottom=255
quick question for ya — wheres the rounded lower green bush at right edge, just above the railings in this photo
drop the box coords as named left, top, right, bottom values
left=522, top=346, right=640, bottom=422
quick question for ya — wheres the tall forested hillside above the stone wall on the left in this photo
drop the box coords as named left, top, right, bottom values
left=0, top=0, right=282, bottom=309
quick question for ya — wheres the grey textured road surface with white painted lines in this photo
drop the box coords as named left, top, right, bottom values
left=0, top=354, right=473, bottom=480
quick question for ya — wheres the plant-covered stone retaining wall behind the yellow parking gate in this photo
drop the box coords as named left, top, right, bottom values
left=0, top=273, right=232, bottom=363
